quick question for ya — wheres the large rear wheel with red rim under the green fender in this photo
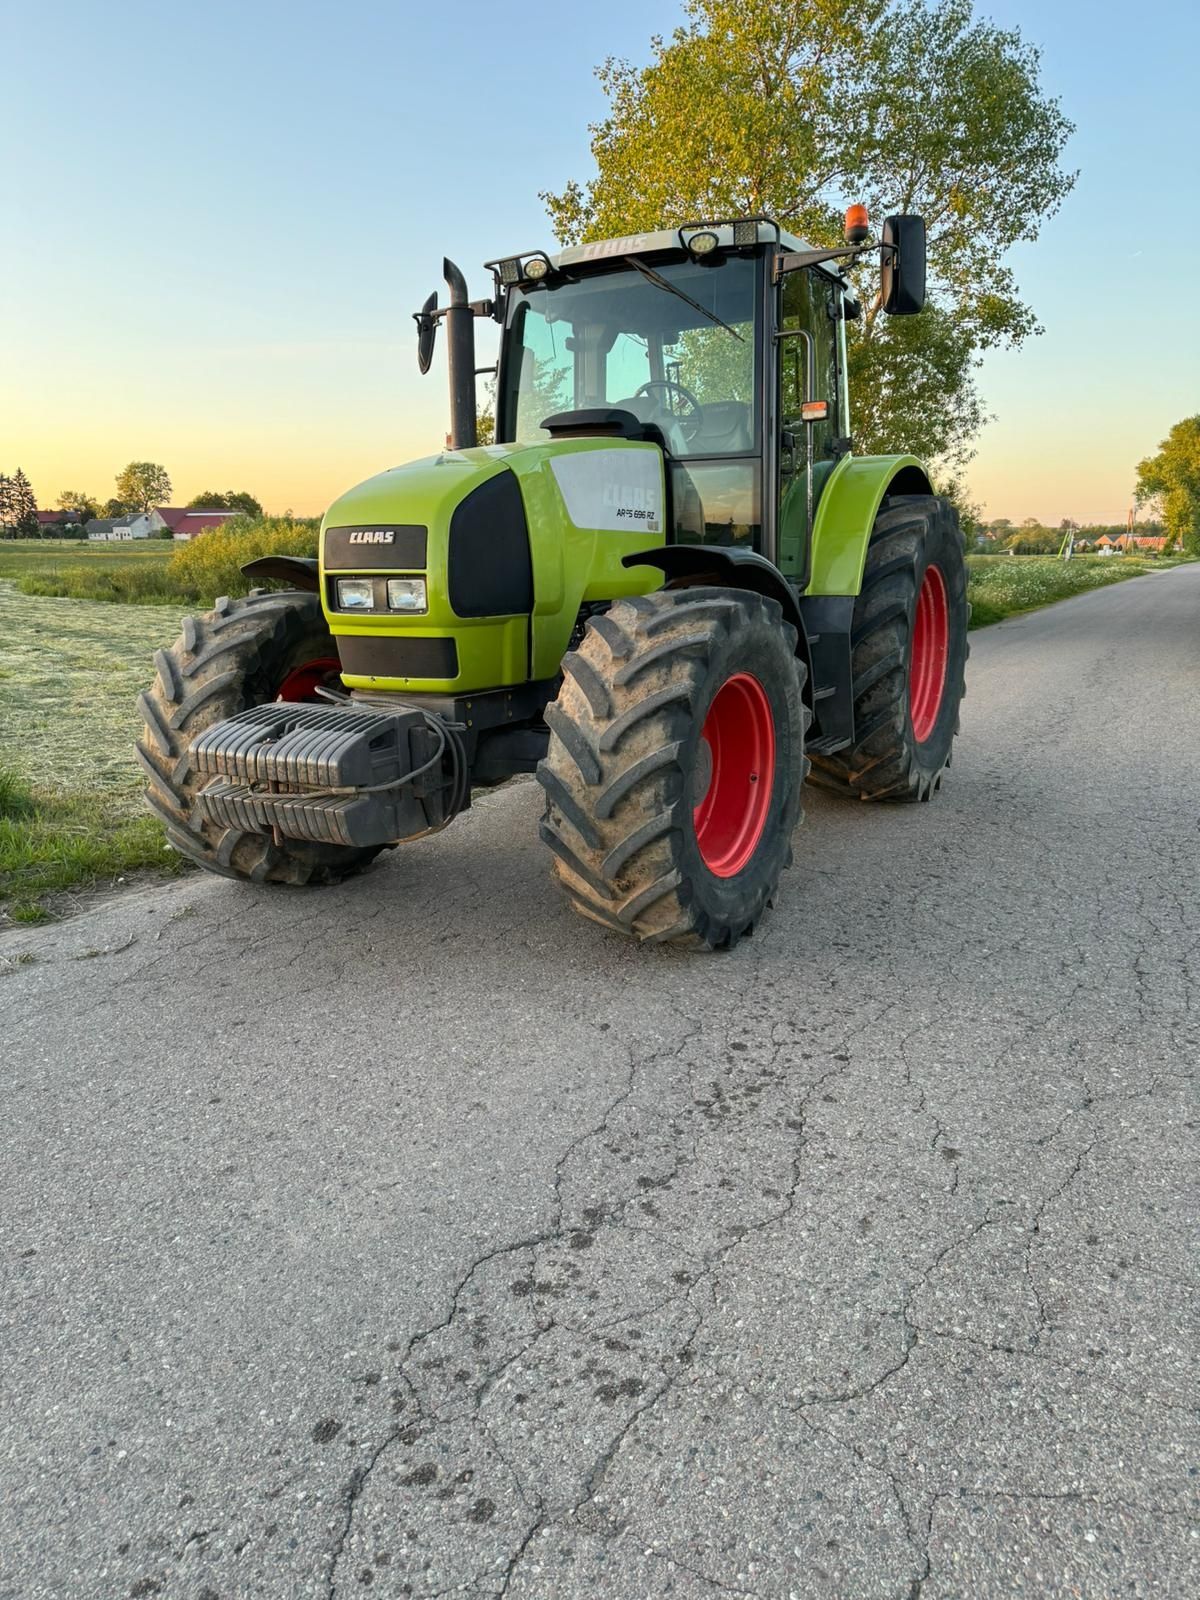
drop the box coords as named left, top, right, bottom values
left=811, top=494, right=971, bottom=802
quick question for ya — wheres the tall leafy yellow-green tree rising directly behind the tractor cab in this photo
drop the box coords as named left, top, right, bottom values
left=542, top=0, right=1075, bottom=462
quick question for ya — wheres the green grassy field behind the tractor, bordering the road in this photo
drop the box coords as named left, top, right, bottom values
left=0, top=528, right=1190, bottom=923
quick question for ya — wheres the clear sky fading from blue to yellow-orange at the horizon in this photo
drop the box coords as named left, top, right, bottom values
left=0, top=0, right=1200, bottom=525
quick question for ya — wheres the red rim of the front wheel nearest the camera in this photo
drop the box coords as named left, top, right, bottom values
left=691, top=672, right=774, bottom=878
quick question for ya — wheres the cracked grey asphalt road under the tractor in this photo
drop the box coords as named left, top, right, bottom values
left=0, top=566, right=1200, bottom=1600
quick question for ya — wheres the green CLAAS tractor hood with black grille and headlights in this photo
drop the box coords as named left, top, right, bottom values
left=320, top=437, right=666, bottom=693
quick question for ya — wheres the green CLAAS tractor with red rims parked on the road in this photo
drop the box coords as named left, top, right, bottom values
left=138, top=206, right=968, bottom=949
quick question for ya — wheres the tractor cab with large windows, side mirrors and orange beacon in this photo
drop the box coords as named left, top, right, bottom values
left=418, top=206, right=925, bottom=587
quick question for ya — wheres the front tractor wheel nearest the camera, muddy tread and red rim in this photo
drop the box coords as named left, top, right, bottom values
left=538, top=587, right=806, bottom=949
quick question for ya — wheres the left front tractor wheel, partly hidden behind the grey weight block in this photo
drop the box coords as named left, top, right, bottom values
left=138, top=590, right=382, bottom=883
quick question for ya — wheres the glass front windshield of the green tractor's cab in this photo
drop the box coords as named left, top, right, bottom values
left=498, top=256, right=760, bottom=459
